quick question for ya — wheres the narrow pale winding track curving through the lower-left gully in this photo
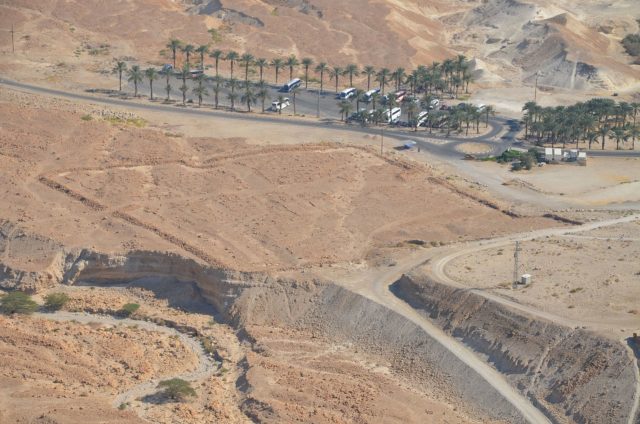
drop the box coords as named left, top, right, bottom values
left=35, top=311, right=215, bottom=417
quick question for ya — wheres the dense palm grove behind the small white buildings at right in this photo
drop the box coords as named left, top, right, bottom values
left=522, top=98, right=640, bottom=150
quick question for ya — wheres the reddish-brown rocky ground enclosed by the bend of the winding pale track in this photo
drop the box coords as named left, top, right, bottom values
left=0, top=316, right=197, bottom=423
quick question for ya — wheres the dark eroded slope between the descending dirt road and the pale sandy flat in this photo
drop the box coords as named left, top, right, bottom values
left=392, top=273, right=636, bottom=423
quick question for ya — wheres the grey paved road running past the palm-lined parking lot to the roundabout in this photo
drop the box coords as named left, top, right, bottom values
left=0, top=78, right=515, bottom=160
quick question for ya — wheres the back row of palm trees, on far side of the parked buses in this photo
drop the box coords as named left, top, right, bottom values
left=166, top=39, right=473, bottom=97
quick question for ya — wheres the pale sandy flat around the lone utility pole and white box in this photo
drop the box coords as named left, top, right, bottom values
left=446, top=221, right=640, bottom=333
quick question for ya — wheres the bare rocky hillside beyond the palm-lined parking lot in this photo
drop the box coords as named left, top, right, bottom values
left=0, top=0, right=640, bottom=107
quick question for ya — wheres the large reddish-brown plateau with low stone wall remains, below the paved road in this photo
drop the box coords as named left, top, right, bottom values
left=0, top=88, right=551, bottom=270
